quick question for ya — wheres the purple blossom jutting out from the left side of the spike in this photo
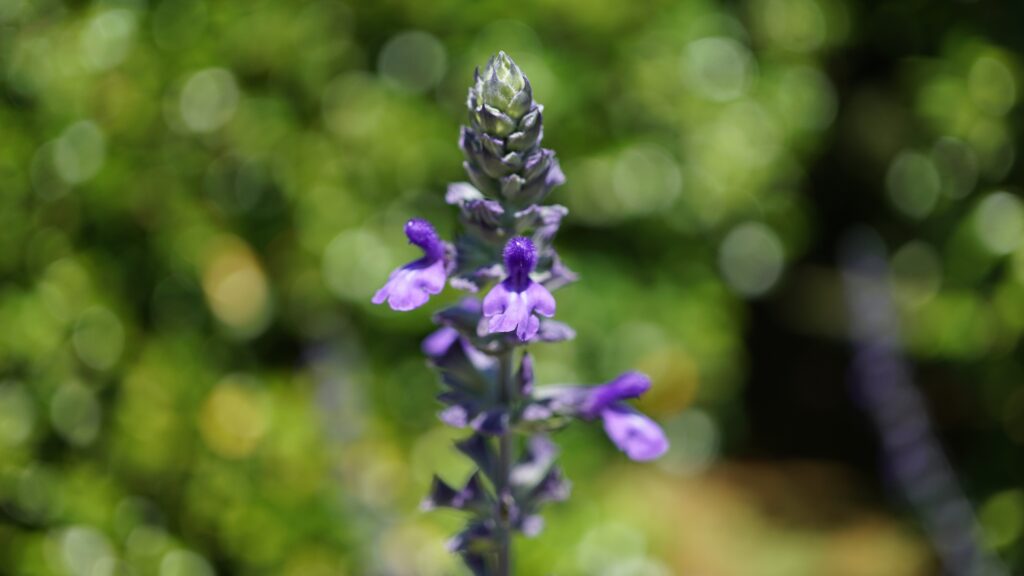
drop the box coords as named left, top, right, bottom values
left=373, top=218, right=447, bottom=312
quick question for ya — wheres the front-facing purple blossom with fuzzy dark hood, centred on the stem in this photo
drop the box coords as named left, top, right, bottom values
left=483, top=237, right=555, bottom=342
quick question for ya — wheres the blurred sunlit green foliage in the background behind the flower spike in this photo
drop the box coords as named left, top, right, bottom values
left=0, top=0, right=1024, bottom=576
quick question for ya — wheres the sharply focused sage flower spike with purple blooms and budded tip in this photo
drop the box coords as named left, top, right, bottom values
left=373, top=52, right=669, bottom=576
